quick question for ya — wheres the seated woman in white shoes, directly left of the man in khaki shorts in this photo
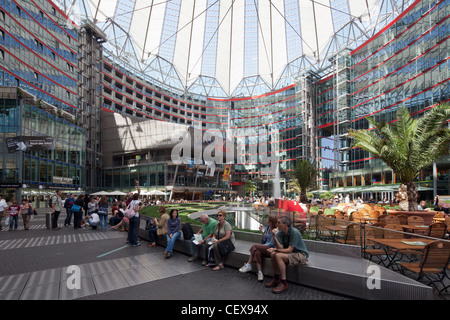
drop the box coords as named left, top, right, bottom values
left=239, top=214, right=278, bottom=281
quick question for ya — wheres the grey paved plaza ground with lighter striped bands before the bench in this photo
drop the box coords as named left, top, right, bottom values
left=0, top=211, right=349, bottom=301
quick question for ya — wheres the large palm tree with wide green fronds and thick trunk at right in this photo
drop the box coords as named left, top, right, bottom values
left=349, top=104, right=450, bottom=211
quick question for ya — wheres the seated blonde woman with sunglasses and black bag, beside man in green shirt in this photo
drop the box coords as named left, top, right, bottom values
left=206, top=210, right=235, bottom=271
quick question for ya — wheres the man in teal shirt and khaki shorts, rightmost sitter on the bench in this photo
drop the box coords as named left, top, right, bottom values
left=266, top=216, right=309, bottom=293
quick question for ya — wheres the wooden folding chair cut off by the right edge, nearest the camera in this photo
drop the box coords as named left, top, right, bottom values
left=398, top=240, right=450, bottom=300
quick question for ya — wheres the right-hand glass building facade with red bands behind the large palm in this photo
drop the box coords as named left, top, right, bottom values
left=319, top=0, right=450, bottom=198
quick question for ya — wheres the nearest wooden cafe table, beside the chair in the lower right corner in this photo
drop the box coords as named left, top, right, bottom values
left=367, top=237, right=436, bottom=268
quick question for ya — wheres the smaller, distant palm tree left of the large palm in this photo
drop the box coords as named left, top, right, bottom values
left=288, top=160, right=317, bottom=203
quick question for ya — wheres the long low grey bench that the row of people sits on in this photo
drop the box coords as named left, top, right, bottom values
left=139, top=217, right=433, bottom=300
